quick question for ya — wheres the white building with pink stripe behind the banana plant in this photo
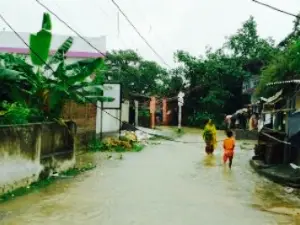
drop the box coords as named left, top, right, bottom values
left=0, top=31, right=106, bottom=63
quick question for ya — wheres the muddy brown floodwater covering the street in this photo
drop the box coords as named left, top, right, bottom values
left=0, top=134, right=300, bottom=225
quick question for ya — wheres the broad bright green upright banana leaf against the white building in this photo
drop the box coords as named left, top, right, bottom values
left=30, top=29, right=52, bottom=66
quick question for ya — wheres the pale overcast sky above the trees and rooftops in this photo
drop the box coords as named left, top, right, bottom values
left=0, top=0, right=300, bottom=66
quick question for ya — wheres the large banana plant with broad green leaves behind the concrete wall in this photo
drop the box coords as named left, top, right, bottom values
left=0, top=13, right=114, bottom=119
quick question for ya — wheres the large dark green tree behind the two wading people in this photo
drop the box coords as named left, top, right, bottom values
left=171, top=17, right=277, bottom=125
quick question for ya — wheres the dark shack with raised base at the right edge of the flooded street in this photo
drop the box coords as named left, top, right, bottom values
left=250, top=80, right=300, bottom=186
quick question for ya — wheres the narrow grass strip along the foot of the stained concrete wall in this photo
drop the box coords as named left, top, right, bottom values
left=0, top=164, right=96, bottom=203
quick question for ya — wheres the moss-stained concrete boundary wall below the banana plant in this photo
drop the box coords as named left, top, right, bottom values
left=0, top=122, right=76, bottom=195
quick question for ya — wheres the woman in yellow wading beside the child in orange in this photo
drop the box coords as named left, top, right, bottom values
left=203, top=119, right=217, bottom=155
